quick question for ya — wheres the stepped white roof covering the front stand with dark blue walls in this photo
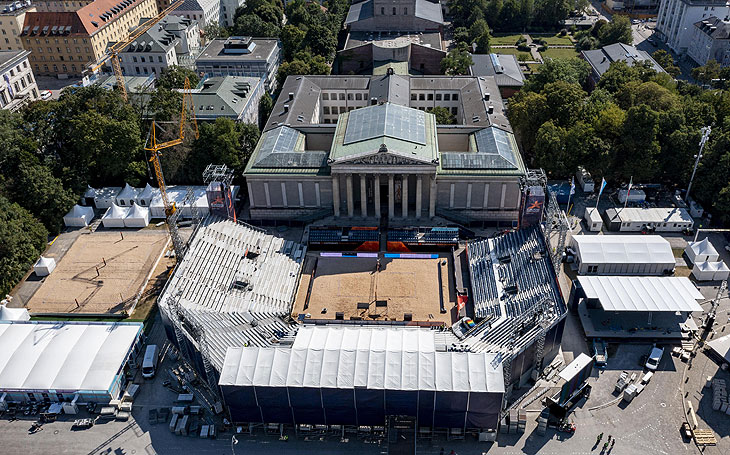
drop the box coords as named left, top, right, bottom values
left=219, top=326, right=504, bottom=392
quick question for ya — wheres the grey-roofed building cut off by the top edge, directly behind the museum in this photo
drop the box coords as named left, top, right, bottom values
left=345, top=0, right=444, bottom=32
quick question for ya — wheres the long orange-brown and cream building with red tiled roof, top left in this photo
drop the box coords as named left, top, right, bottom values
left=21, top=0, right=157, bottom=78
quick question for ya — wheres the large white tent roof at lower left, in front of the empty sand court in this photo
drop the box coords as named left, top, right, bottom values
left=0, top=321, right=142, bottom=391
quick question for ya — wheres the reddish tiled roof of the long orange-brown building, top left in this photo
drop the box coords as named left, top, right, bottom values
left=22, top=0, right=149, bottom=36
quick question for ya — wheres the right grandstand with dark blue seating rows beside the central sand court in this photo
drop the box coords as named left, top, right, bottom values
left=462, top=227, right=567, bottom=392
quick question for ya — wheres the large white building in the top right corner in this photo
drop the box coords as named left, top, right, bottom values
left=656, top=0, right=730, bottom=54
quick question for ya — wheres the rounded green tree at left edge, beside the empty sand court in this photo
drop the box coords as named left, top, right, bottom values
left=0, top=196, right=48, bottom=295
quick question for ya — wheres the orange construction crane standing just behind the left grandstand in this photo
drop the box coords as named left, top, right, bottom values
left=145, top=78, right=200, bottom=260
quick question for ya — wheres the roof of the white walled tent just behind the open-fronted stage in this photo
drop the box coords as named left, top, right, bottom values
left=573, top=235, right=675, bottom=264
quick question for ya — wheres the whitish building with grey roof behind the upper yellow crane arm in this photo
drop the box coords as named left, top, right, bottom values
left=115, top=16, right=200, bottom=76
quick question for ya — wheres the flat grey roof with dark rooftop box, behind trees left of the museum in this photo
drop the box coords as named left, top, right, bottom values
left=195, top=36, right=281, bottom=63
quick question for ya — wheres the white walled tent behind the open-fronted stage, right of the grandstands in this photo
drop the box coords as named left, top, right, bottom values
left=570, top=235, right=676, bottom=275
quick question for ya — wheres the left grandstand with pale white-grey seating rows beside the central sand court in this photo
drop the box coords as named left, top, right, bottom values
left=159, top=216, right=306, bottom=384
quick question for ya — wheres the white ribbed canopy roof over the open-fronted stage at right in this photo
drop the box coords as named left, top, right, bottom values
left=578, top=276, right=704, bottom=312
